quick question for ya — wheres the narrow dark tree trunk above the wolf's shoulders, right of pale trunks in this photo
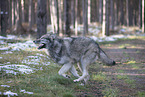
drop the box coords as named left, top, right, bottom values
left=64, top=0, right=71, bottom=36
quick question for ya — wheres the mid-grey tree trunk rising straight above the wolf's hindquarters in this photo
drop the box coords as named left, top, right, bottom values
left=82, top=0, right=88, bottom=36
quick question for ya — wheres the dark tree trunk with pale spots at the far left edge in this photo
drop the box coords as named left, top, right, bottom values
left=0, top=0, right=9, bottom=36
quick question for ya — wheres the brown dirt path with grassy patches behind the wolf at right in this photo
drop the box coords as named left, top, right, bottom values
left=77, top=39, right=145, bottom=97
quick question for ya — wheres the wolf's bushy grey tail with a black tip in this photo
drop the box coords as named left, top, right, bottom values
left=99, top=48, right=116, bottom=66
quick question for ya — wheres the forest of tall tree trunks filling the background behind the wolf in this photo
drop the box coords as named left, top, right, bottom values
left=0, top=0, right=145, bottom=37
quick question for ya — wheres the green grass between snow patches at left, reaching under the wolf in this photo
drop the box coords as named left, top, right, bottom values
left=0, top=47, right=85, bottom=97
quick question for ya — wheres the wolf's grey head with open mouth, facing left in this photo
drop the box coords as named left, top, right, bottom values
left=33, top=34, right=57, bottom=49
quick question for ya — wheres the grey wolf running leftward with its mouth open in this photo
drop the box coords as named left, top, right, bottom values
left=33, top=33, right=115, bottom=83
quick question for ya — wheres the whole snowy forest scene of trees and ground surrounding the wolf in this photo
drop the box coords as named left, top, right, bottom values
left=0, top=0, right=145, bottom=97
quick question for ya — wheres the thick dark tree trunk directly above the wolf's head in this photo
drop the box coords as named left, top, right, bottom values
left=37, top=0, right=47, bottom=38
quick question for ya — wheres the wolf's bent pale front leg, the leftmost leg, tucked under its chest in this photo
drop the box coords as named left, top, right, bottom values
left=58, top=63, right=72, bottom=78
